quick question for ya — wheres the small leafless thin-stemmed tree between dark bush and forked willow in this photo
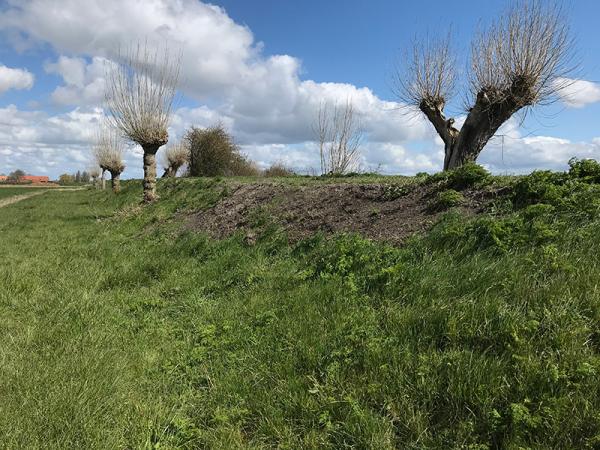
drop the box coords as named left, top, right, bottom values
left=314, top=100, right=363, bottom=175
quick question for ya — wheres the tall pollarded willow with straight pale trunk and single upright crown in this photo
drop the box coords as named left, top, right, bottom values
left=106, top=44, right=181, bottom=203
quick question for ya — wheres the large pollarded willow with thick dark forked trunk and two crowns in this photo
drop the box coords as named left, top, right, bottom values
left=395, top=0, right=574, bottom=170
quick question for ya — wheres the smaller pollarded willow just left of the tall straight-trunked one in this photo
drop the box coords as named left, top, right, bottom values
left=92, top=125, right=125, bottom=192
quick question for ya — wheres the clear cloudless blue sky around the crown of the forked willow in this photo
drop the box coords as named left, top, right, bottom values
left=215, top=0, right=600, bottom=140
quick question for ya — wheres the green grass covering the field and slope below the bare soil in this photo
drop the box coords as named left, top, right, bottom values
left=0, top=171, right=600, bottom=450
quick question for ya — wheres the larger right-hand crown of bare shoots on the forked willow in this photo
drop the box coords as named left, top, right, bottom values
left=470, top=0, right=575, bottom=109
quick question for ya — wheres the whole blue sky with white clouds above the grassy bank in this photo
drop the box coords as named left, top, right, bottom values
left=0, top=0, right=600, bottom=178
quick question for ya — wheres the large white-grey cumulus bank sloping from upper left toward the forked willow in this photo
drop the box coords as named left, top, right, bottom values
left=0, top=0, right=428, bottom=145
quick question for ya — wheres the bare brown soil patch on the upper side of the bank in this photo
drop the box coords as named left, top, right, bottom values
left=190, top=183, right=493, bottom=243
